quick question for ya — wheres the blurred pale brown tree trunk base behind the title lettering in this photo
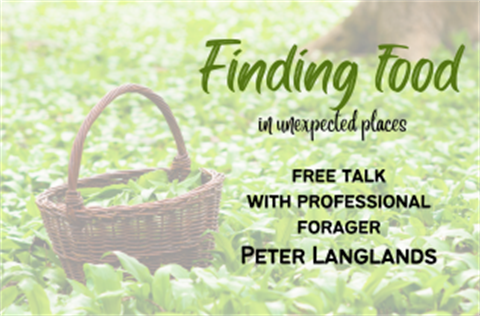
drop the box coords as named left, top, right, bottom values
left=306, top=0, right=479, bottom=60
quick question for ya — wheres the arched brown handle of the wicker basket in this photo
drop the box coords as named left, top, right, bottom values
left=65, top=83, right=190, bottom=216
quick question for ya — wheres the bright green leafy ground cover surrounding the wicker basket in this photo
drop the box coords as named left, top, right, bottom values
left=1, top=2, right=480, bottom=315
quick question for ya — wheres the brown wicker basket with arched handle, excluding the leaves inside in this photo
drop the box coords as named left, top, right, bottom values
left=36, top=84, right=224, bottom=282
